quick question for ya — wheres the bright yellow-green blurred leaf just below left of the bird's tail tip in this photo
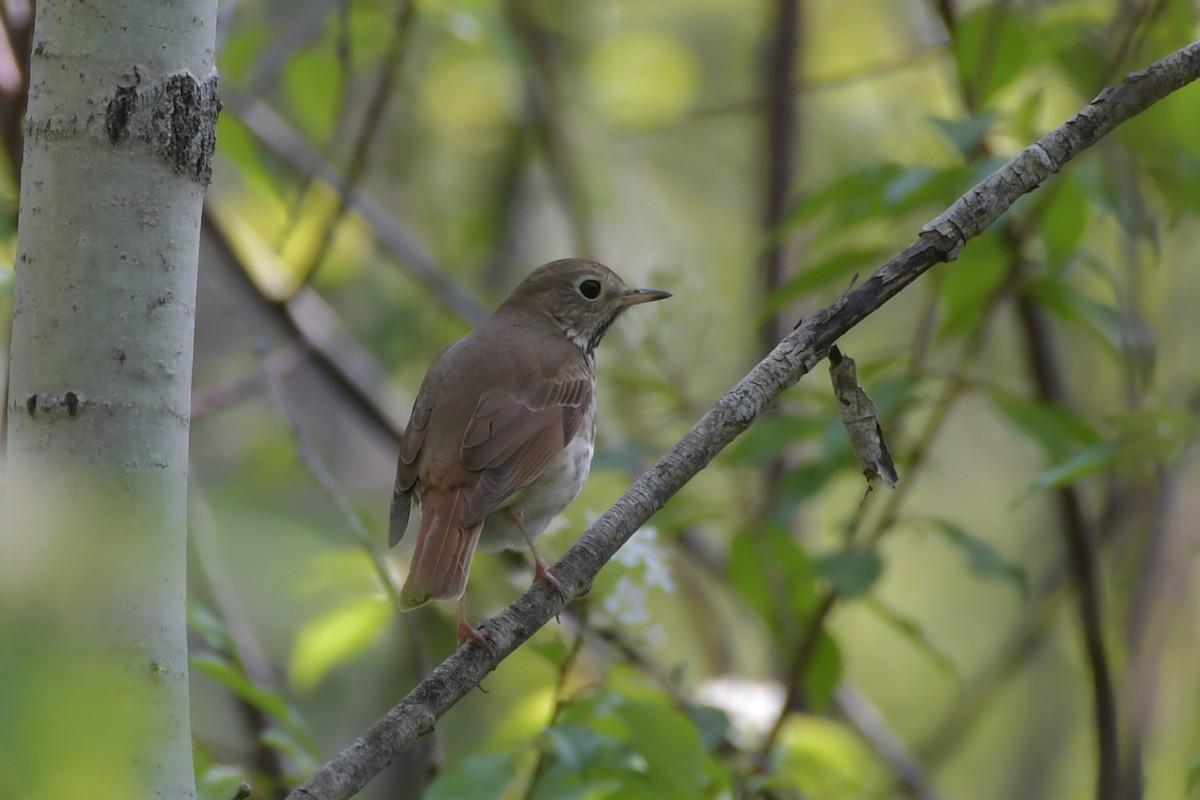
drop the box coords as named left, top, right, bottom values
left=288, top=595, right=394, bottom=691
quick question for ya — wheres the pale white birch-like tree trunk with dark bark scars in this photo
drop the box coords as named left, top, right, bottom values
left=0, top=0, right=220, bottom=799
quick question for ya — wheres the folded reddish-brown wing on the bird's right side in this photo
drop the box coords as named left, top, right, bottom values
left=462, top=354, right=594, bottom=525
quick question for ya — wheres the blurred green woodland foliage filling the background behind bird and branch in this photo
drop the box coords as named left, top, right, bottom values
left=0, top=0, right=1200, bottom=800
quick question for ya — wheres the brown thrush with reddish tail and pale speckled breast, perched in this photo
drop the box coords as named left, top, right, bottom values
left=389, top=258, right=671, bottom=646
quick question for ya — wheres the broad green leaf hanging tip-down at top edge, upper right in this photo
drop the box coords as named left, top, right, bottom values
left=953, top=4, right=1028, bottom=108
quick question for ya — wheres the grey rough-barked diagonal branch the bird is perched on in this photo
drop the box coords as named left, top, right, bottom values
left=290, top=41, right=1200, bottom=800
